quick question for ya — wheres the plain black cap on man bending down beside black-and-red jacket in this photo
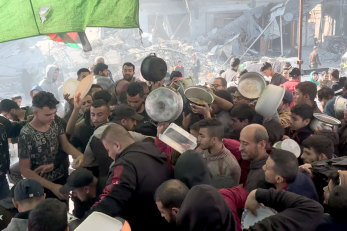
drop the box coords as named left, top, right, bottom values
left=59, top=168, right=94, bottom=194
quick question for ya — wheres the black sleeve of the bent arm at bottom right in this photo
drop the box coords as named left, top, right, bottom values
left=249, top=189, right=323, bottom=231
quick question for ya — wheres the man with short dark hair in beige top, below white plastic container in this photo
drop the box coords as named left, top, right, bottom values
left=197, top=119, right=241, bottom=182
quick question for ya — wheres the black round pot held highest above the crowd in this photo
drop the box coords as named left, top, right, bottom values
left=141, top=53, right=167, bottom=82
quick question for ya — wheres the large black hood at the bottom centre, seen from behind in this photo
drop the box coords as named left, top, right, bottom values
left=176, top=185, right=236, bottom=231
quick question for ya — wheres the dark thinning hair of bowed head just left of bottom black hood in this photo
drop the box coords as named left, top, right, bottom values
left=154, top=180, right=189, bottom=209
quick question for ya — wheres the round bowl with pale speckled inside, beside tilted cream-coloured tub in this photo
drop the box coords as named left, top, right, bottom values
left=237, top=72, right=266, bottom=100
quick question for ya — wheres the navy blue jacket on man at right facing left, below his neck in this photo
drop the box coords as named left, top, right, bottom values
left=286, top=171, right=319, bottom=201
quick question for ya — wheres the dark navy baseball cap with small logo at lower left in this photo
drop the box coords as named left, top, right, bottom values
left=14, top=179, right=45, bottom=201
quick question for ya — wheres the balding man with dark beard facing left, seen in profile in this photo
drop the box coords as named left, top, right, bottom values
left=240, top=124, right=269, bottom=192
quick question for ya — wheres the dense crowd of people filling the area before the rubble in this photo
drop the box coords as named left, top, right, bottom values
left=0, top=55, right=347, bottom=231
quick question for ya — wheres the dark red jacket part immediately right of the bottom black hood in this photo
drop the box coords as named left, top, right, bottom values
left=218, top=186, right=248, bottom=231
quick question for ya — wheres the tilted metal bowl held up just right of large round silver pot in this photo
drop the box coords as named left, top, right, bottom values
left=184, top=86, right=214, bottom=106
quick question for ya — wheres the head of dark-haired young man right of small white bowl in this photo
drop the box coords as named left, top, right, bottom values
left=301, top=135, right=334, bottom=164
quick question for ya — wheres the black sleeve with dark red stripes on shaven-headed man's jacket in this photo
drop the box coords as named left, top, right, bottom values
left=88, top=163, right=137, bottom=217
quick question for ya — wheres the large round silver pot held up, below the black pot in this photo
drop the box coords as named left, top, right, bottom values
left=145, top=87, right=183, bottom=123
